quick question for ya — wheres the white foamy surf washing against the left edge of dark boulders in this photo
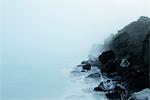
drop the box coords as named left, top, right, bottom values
left=61, top=67, right=107, bottom=100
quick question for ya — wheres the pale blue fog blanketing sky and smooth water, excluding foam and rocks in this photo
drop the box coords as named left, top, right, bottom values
left=0, top=0, right=150, bottom=100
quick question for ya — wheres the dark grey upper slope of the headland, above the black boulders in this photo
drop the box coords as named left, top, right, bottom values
left=110, top=17, right=150, bottom=65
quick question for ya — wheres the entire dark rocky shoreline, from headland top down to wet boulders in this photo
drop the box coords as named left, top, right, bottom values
left=74, top=16, right=150, bottom=100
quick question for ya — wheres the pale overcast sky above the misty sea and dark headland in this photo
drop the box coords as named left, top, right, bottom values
left=2, top=0, right=149, bottom=50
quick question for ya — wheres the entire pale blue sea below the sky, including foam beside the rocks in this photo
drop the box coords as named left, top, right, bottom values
left=0, top=38, right=107, bottom=100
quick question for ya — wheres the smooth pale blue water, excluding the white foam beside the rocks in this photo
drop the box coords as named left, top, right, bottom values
left=1, top=44, right=89, bottom=100
